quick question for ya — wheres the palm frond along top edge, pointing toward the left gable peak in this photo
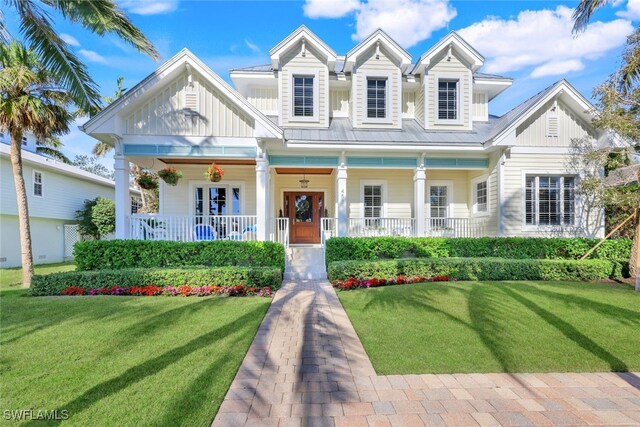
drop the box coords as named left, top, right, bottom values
left=42, top=0, right=160, bottom=60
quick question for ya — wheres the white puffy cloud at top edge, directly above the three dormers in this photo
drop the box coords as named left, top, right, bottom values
left=303, top=0, right=457, bottom=48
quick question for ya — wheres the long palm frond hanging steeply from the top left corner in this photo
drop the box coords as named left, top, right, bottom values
left=13, top=0, right=100, bottom=111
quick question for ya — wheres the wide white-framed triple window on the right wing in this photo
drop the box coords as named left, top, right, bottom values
left=524, top=175, right=575, bottom=225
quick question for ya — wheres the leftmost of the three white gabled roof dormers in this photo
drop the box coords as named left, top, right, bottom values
left=269, top=25, right=337, bottom=128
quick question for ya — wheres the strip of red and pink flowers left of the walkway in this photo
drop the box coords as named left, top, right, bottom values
left=55, top=285, right=272, bottom=297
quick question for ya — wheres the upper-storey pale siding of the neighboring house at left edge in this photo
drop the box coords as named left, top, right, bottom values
left=0, top=157, right=115, bottom=222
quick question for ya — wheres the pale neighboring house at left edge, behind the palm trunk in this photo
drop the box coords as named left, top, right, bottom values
left=0, top=131, right=138, bottom=268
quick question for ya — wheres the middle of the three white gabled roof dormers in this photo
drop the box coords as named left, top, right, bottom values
left=343, top=30, right=411, bottom=129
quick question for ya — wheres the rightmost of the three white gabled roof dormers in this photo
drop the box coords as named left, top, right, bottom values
left=412, top=31, right=488, bottom=130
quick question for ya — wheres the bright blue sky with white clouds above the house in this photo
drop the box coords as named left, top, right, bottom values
left=3, top=0, right=640, bottom=166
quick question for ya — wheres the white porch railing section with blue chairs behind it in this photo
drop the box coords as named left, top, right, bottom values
left=129, top=214, right=257, bottom=242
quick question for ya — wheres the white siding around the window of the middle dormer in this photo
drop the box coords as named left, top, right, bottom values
left=352, top=47, right=402, bottom=129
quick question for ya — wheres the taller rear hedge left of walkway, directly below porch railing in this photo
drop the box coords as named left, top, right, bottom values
left=73, top=240, right=284, bottom=271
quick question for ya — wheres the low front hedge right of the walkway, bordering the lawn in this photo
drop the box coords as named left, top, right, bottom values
left=327, top=258, right=615, bottom=281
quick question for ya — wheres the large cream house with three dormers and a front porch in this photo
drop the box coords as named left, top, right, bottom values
left=83, top=26, right=606, bottom=247
